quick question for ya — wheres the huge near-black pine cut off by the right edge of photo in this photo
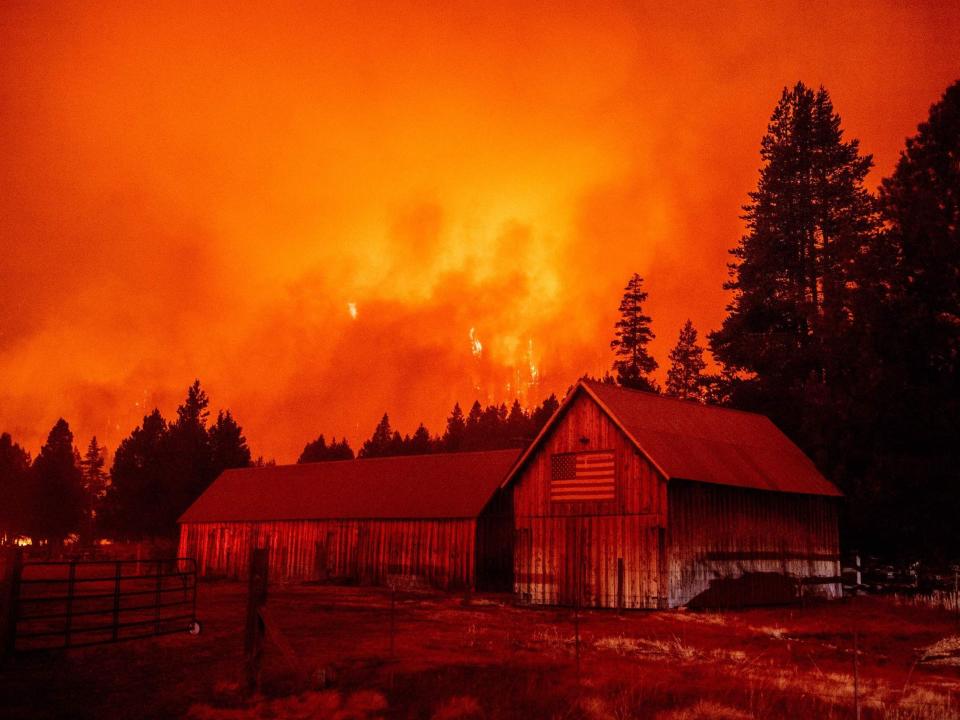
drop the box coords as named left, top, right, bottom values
left=848, top=81, right=960, bottom=558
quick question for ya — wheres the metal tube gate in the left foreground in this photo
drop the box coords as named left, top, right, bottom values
left=6, top=558, right=200, bottom=652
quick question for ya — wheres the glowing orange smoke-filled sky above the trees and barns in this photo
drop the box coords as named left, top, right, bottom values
left=0, top=1, right=960, bottom=462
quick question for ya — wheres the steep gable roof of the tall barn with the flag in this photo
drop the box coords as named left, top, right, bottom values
left=504, top=380, right=841, bottom=497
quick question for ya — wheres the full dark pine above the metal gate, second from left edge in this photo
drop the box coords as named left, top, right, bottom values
left=30, top=418, right=85, bottom=546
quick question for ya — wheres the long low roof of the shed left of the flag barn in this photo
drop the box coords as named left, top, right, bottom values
left=180, top=450, right=520, bottom=523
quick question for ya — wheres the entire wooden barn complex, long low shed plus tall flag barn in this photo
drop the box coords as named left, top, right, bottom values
left=180, top=382, right=840, bottom=608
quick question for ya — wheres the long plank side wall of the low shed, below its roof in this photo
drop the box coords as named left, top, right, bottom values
left=180, top=520, right=476, bottom=589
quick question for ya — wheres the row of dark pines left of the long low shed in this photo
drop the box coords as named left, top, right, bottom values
left=0, top=380, right=251, bottom=546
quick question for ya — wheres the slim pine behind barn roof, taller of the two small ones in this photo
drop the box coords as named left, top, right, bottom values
left=610, top=273, right=657, bottom=392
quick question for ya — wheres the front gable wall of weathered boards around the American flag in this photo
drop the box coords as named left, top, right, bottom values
left=512, top=394, right=667, bottom=608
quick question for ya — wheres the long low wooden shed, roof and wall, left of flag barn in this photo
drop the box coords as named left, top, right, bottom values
left=179, top=450, right=519, bottom=589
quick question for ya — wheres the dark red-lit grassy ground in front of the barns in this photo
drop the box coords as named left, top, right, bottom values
left=0, top=583, right=960, bottom=720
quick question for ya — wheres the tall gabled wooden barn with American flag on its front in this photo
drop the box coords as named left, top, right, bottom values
left=502, top=382, right=841, bottom=608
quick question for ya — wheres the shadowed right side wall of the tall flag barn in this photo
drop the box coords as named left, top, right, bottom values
left=668, top=480, right=841, bottom=607
